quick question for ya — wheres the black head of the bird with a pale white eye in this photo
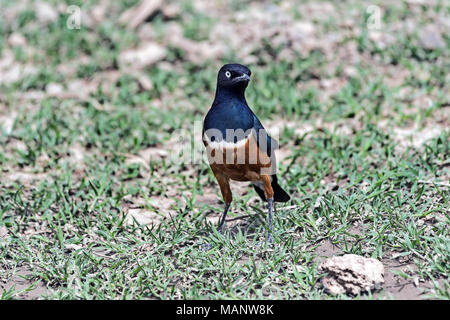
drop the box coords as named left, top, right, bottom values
left=217, top=63, right=252, bottom=92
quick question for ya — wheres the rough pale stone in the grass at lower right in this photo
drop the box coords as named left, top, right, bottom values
left=318, top=254, right=384, bottom=295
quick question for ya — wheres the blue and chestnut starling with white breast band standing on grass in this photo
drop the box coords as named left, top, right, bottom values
left=202, top=63, right=290, bottom=245
